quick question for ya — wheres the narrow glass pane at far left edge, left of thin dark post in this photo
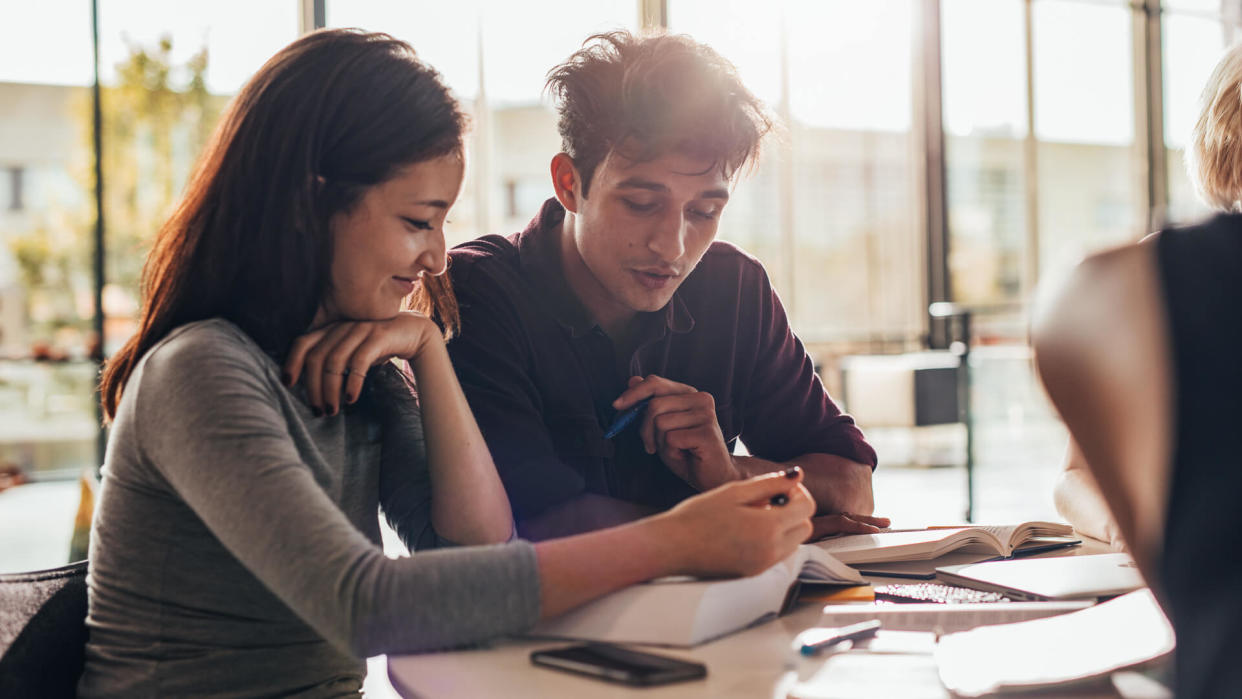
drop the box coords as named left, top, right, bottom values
left=0, top=0, right=98, bottom=491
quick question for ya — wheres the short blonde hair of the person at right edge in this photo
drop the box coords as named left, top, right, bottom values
left=1186, top=43, right=1242, bottom=211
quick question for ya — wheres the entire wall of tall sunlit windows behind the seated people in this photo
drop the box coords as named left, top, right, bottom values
left=0, top=0, right=1242, bottom=558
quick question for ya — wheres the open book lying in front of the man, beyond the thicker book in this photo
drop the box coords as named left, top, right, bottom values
left=812, top=521, right=1073, bottom=566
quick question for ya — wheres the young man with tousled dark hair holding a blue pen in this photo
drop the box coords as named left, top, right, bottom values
left=450, top=32, right=887, bottom=539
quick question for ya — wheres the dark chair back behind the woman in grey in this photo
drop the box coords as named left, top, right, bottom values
left=0, top=561, right=87, bottom=698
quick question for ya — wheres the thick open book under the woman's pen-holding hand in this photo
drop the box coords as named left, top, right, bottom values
left=530, top=545, right=864, bottom=646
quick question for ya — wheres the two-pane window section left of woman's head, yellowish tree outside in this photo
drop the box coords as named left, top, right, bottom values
left=0, top=0, right=298, bottom=478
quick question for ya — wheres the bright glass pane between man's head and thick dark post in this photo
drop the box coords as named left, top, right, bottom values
left=787, top=0, right=923, bottom=340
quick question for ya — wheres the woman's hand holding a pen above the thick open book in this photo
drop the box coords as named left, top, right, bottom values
left=652, top=467, right=815, bottom=577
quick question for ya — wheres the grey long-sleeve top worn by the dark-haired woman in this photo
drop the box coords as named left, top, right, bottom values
left=79, top=319, right=539, bottom=697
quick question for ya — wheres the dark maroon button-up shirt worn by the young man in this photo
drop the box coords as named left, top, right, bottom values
left=448, top=199, right=876, bottom=521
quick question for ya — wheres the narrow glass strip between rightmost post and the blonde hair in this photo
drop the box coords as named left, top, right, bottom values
left=1161, top=14, right=1228, bottom=222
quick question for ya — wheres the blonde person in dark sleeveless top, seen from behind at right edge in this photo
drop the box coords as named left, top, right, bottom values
left=1032, top=39, right=1242, bottom=699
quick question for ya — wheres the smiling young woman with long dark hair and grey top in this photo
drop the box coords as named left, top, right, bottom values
left=79, top=31, right=815, bottom=697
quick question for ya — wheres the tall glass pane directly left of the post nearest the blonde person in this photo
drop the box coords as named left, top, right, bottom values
left=1032, top=0, right=1146, bottom=277
